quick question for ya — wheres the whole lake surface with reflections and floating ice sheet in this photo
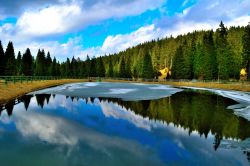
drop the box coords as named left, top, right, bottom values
left=0, top=83, right=250, bottom=166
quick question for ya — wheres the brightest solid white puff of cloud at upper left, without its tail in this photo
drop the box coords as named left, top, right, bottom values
left=16, top=5, right=81, bottom=36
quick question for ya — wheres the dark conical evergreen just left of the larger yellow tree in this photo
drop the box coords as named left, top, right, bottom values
left=142, top=52, right=154, bottom=78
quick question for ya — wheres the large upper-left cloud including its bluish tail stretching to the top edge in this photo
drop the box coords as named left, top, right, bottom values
left=16, top=0, right=163, bottom=37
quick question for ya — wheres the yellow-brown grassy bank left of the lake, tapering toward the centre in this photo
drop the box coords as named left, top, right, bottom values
left=0, top=79, right=87, bottom=104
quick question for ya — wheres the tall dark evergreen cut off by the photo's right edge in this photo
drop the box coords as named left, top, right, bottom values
left=242, top=22, right=250, bottom=79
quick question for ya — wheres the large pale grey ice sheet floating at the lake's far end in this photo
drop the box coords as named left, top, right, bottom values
left=30, top=82, right=182, bottom=101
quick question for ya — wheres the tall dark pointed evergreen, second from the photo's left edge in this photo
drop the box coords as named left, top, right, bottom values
left=4, top=42, right=16, bottom=75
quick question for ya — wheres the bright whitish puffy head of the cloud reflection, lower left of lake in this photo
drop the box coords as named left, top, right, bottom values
left=15, top=112, right=78, bottom=145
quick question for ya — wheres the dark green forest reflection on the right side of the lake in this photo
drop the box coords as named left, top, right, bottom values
left=106, top=92, right=250, bottom=141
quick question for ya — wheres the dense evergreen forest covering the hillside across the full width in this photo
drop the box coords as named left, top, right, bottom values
left=0, top=22, right=250, bottom=80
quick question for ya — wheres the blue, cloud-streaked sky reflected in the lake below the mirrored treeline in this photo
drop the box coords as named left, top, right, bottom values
left=0, top=95, right=247, bottom=165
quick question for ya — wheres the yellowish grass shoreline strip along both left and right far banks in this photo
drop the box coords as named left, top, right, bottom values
left=0, top=79, right=250, bottom=104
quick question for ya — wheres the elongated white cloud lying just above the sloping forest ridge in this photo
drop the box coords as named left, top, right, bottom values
left=85, top=22, right=212, bottom=56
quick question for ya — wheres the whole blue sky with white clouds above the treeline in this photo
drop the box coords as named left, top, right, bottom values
left=0, top=0, right=250, bottom=61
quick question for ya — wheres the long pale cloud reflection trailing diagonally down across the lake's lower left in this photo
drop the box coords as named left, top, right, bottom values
left=11, top=109, right=163, bottom=163
